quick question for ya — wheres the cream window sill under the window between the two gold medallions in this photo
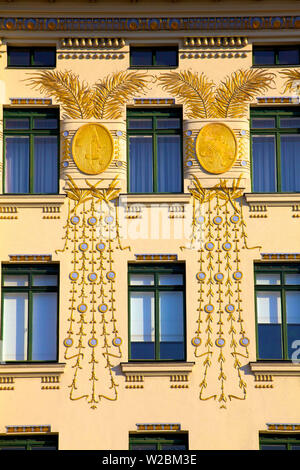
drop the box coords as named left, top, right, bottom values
left=120, top=193, right=191, bottom=204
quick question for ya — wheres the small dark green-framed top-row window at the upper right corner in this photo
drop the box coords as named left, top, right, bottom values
left=252, top=45, right=300, bottom=67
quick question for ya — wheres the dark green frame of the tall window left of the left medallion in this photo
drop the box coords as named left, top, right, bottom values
left=2, top=107, right=60, bottom=195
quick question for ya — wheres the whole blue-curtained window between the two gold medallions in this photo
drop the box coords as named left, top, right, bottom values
left=127, top=109, right=182, bottom=193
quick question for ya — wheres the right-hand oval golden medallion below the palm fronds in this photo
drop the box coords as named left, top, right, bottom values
left=196, top=123, right=237, bottom=173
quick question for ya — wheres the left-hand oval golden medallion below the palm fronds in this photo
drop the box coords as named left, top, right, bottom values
left=72, top=124, right=114, bottom=175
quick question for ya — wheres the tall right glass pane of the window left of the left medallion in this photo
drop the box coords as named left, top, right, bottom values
left=34, top=136, right=58, bottom=193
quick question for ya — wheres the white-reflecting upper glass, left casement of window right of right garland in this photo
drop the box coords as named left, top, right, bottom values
left=256, top=291, right=281, bottom=323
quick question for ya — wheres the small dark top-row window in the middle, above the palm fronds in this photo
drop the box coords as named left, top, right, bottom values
left=130, top=46, right=178, bottom=68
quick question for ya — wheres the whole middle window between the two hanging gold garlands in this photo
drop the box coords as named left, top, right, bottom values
left=129, top=265, right=185, bottom=361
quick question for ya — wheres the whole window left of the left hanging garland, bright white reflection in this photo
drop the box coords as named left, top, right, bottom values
left=1, top=265, right=58, bottom=362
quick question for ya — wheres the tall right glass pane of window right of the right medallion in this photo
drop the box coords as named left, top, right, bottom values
left=280, top=135, right=300, bottom=191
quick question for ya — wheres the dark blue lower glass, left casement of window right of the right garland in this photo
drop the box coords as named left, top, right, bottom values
left=258, top=324, right=282, bottom=359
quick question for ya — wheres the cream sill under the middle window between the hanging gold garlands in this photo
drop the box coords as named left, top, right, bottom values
left=121, top=361, right=195, bottom=377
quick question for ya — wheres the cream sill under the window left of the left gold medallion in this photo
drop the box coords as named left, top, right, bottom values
left=0, top=194, right=66, bottom=207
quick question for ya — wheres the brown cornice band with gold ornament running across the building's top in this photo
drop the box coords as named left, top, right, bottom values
left=0, top=16, right=300, bottom=32
